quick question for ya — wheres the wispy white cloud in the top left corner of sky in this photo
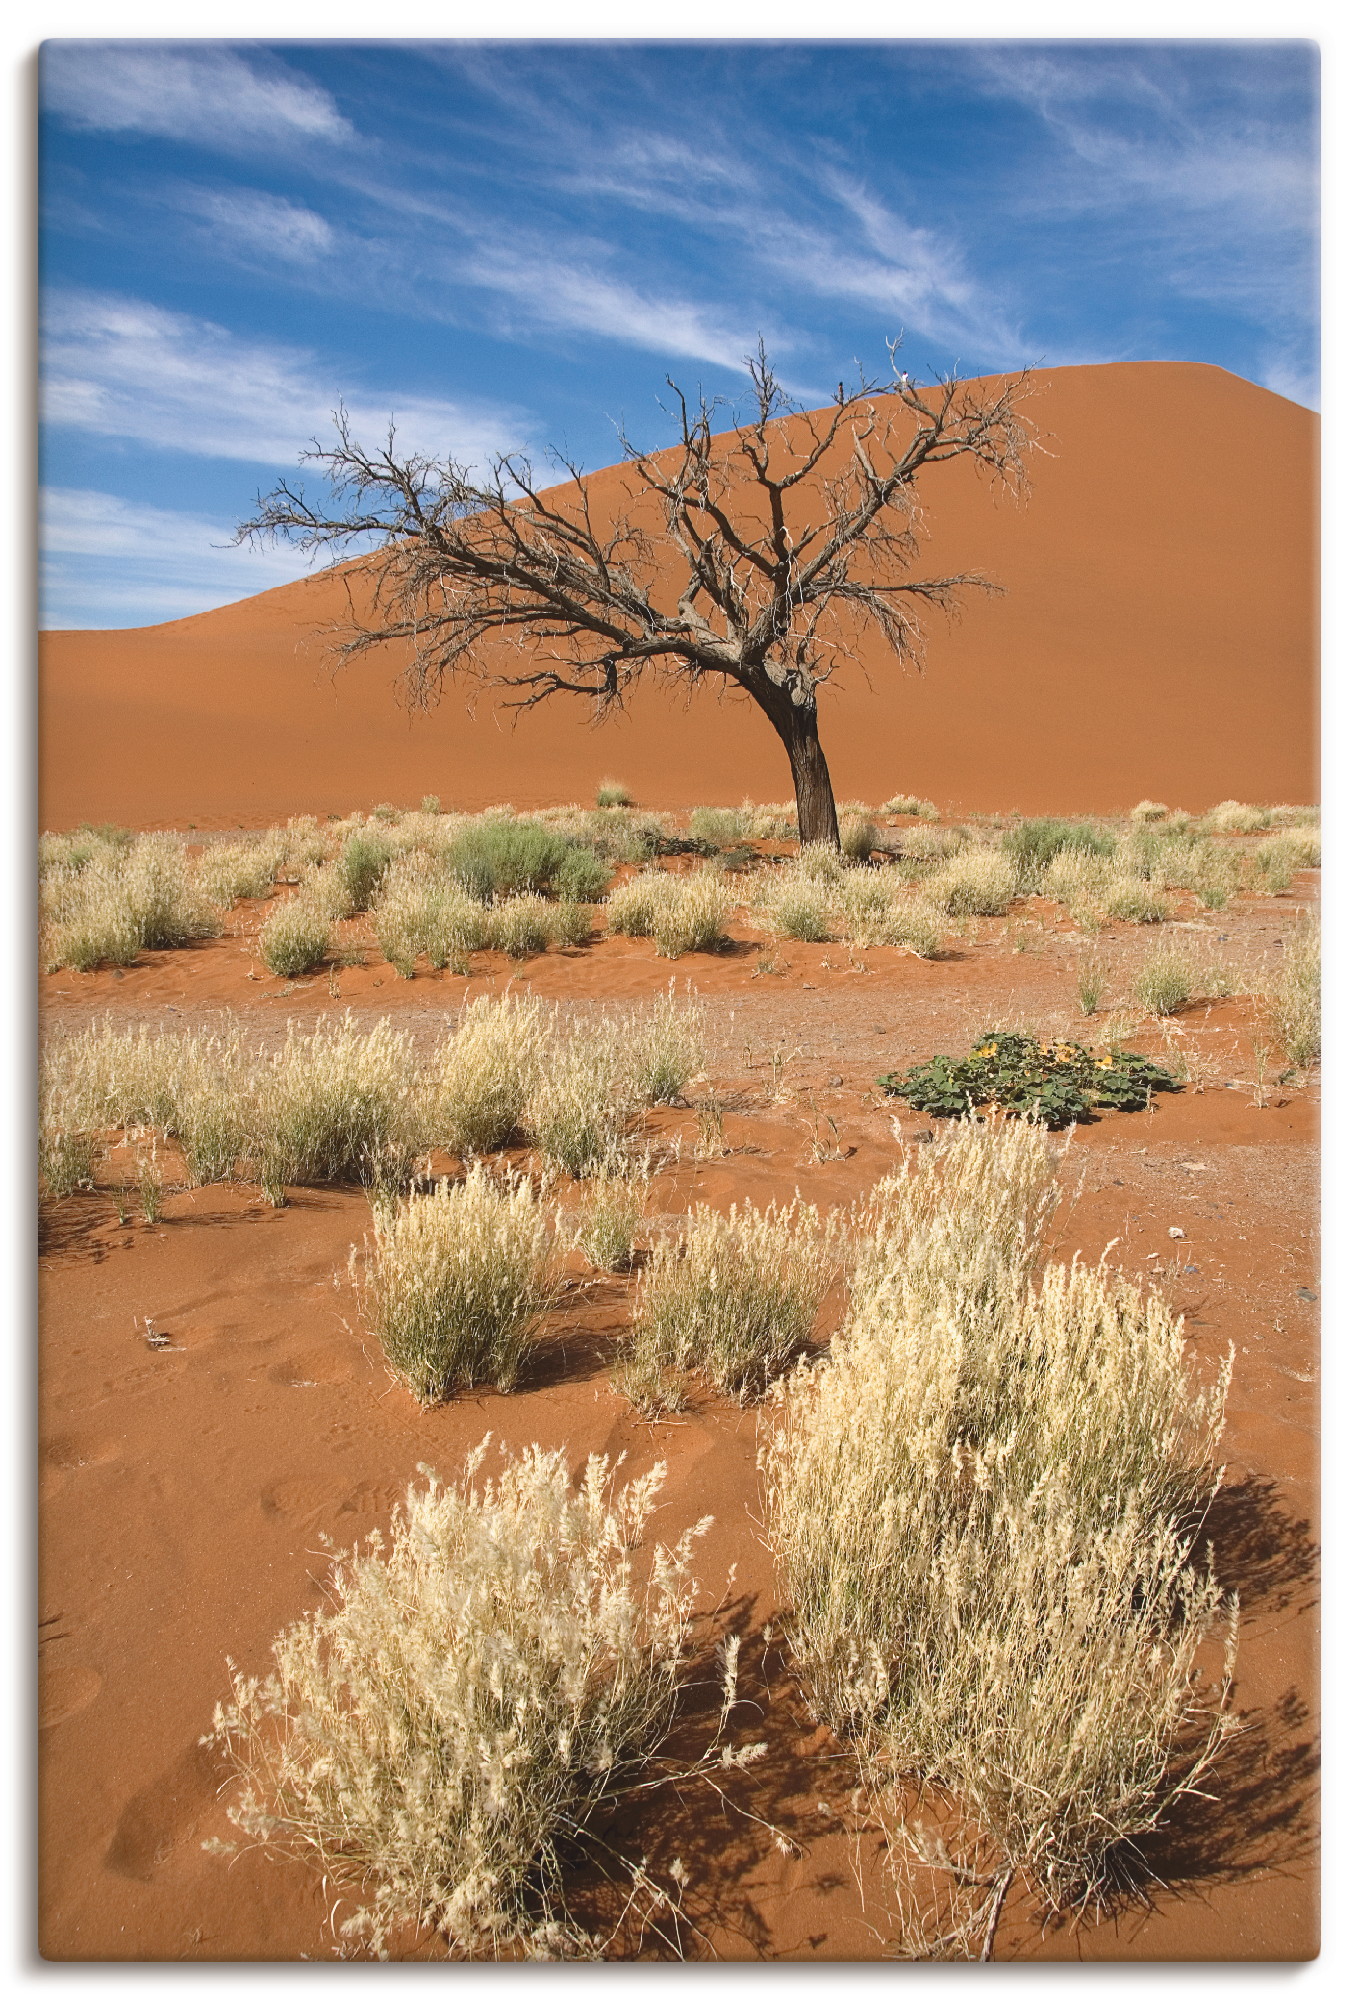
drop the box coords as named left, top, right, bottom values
left=42, top=42, right=356, bottom=152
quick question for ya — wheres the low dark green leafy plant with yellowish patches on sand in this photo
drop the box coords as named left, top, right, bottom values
left=877, top=1030, right=1177, bottom=1130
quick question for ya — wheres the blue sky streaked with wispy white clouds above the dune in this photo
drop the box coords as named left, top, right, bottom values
left=40, top=40, right=1317, bottom=626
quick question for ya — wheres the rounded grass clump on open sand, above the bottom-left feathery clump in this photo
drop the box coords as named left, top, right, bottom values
left=350, top=1160, right=558, bottom=1402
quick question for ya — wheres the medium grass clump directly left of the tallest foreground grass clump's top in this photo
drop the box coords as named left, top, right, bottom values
left=618, top=1202, right=839, bottom=1408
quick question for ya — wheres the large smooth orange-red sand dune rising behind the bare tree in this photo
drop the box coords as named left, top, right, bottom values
left=42, top=362, right=1317, bottom=828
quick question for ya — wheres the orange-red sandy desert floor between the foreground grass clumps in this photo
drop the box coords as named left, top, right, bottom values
left=40, top=874, right=1319, bottom=1960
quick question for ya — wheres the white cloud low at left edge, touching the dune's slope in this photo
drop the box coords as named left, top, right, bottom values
left=40, top=486, right=317, bottom=630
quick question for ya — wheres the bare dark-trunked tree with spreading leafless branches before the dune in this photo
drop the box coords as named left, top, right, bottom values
left=236, top=342, right=1033, bottom=844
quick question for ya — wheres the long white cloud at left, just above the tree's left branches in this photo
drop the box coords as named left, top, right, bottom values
left=42, top=292, right=524, bottom=466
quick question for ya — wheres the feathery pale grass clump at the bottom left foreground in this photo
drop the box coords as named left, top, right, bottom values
left=212, top=1446, right=711, bottom=1958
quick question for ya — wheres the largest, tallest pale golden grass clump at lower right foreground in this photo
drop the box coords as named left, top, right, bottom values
left=763, top=1126, right=1233, bottom=1944
